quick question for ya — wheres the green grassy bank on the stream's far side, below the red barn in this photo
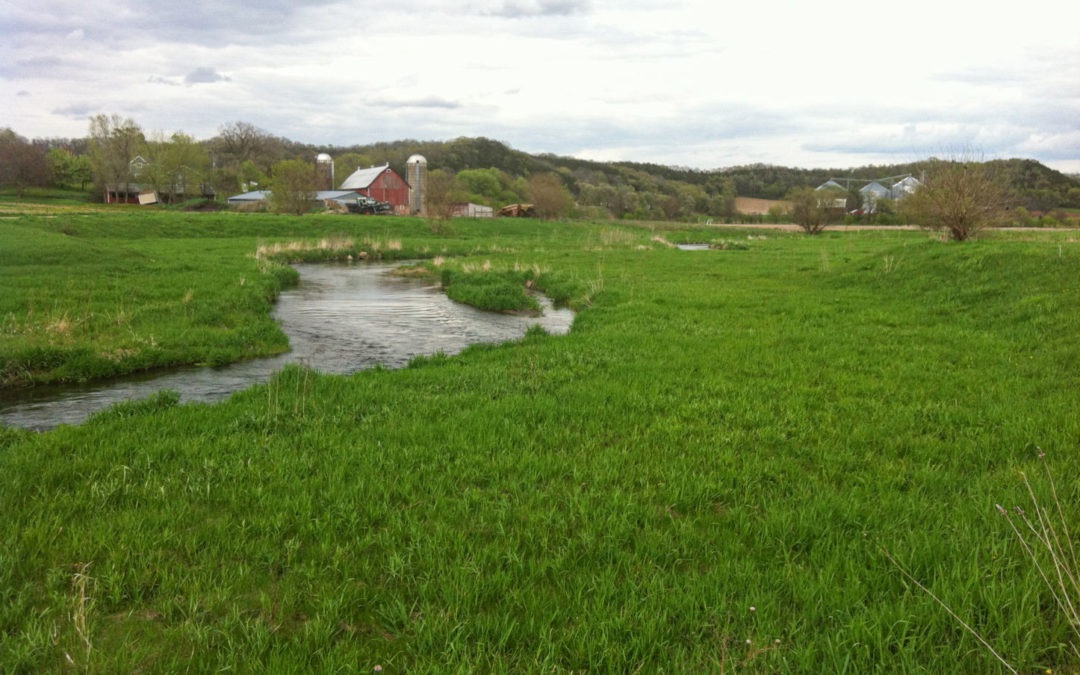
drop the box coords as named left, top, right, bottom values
left=0, top=210, right=580, bottom=388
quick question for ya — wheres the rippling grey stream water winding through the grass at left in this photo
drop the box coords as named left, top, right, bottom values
left=0, top=264, right=573, bottom=430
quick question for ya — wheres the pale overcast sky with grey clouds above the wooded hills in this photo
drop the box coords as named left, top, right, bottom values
left=0, top=0, right=1080, bottom=173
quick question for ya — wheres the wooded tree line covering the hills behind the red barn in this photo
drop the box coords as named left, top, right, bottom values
left=0, top=114, right=1080, bottom=220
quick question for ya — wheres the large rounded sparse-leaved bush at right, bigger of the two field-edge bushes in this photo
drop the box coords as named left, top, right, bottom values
left=903, top=160, right=1013, bottom=241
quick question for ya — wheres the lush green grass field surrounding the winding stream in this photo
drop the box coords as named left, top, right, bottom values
left=0, top=211, right=1080, bottom=674
